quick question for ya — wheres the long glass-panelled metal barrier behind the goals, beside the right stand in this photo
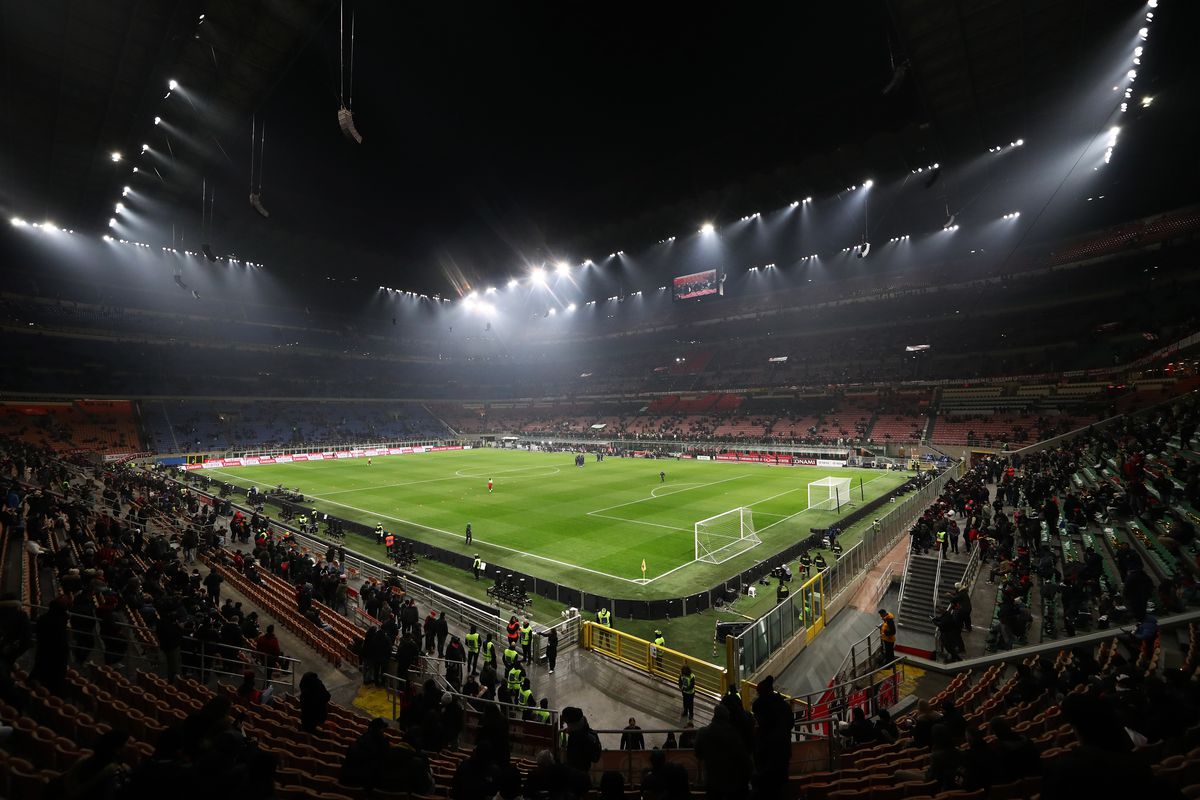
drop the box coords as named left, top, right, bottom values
left=730, top=462, right=962, bottom=679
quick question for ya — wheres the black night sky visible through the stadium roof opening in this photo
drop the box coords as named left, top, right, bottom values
left=214, top=0, right=918, bottom=290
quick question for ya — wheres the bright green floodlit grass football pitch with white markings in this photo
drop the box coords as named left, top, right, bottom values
left=204, top=450, right=907, bottom=600
